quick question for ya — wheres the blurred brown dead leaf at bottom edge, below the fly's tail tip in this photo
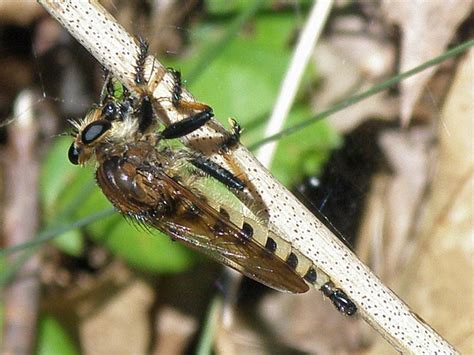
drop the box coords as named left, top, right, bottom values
left=216, top=291, right=366, bottom=354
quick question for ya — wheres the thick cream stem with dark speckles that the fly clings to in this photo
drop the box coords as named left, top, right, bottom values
left=39, top=0, right=456, bottom=354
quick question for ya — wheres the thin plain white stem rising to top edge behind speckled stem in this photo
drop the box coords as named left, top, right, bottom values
left=257, top=0, right=333, bottom=168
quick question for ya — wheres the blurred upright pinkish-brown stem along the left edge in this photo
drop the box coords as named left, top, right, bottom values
left=0, top=92, right=40, bottom=354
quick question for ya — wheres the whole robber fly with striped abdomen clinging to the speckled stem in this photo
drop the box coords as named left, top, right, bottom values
left=68, top=40, right=357, bottom=315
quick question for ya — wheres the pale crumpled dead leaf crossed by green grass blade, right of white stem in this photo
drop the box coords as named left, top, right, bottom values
left=312, top=14, right=399, bottom=133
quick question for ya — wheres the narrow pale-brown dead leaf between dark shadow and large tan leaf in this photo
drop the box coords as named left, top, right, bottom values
left=357, top=126, right=433, bottom=286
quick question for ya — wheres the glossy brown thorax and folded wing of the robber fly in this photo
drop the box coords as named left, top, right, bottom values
left=96, top=157, right=309, bottom=293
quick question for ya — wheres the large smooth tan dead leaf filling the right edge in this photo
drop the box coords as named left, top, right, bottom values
left=374, top=49, right=474, bottom=353
